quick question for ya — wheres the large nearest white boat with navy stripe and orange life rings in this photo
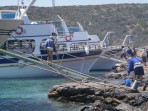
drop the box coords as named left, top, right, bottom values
left=0, top=0, right=102, bottom=78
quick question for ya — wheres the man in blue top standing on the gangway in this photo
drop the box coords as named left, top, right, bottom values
left=46, top=36, right=56, bottom=62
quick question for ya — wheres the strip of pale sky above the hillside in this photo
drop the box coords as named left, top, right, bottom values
left=0, top=0, right=148, bottom=7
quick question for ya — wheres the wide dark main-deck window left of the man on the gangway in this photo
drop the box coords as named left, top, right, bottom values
left=6, top=39, right=35, bottom=53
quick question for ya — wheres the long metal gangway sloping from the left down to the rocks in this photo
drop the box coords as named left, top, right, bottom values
left=0, top=49, right=132, bottom=88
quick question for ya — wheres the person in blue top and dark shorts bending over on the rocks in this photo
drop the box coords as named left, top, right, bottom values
left=128, top=51, right=144, bottom=85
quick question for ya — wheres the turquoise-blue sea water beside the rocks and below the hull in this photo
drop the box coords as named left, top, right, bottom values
left=0, top=73, right=106, bottom=111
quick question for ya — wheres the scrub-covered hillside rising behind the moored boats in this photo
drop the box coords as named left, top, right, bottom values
left=0, top=4, right=148, bottom=47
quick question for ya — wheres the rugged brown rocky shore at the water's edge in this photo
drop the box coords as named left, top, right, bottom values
left=48, top=66, right=148, bottom=111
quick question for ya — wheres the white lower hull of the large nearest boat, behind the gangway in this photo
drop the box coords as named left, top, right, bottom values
left=0, top=55, right=99, bottom=79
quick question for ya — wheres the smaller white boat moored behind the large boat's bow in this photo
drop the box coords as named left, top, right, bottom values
left=91, top=31, right=133, bottom=71
